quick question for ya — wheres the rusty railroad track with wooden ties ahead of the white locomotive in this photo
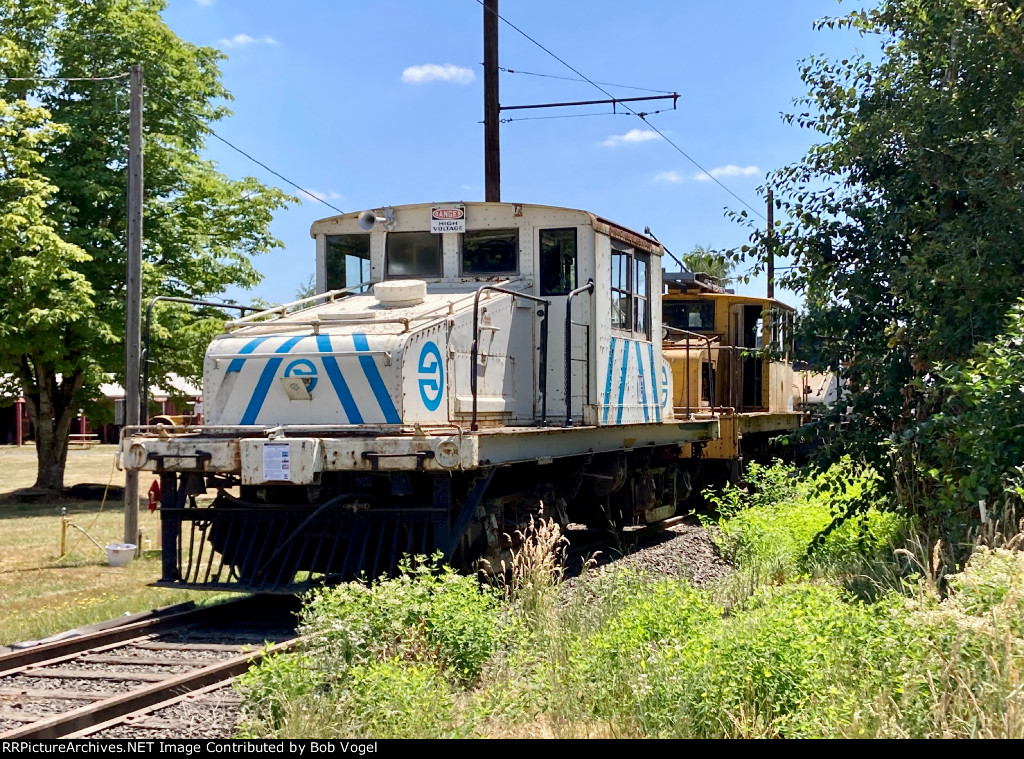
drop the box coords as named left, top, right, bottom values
left=0, top=596, right=297, bottom=740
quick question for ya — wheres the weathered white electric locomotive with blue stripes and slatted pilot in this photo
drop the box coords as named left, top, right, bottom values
left=121, top=203, right=719, bottom=592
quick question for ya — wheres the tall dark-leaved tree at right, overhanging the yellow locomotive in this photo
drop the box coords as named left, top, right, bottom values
left=752, top=0, right=1024, bottom=524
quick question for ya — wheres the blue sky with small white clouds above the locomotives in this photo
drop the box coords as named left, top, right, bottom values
left=164, top=0, right=873, bottom=302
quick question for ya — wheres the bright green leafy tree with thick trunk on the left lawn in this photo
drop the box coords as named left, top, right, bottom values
left=0, top=0, right=289, bottom=489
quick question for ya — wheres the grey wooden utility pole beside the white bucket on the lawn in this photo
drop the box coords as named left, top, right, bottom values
left=124, top=64, right=142, bottom=544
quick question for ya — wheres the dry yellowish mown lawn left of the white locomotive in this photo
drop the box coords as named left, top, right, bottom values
left=0, top=446, right=226, bottom=645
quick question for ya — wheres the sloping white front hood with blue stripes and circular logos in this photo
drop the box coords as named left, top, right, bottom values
left=203, top=294, right=454, bottom=426
